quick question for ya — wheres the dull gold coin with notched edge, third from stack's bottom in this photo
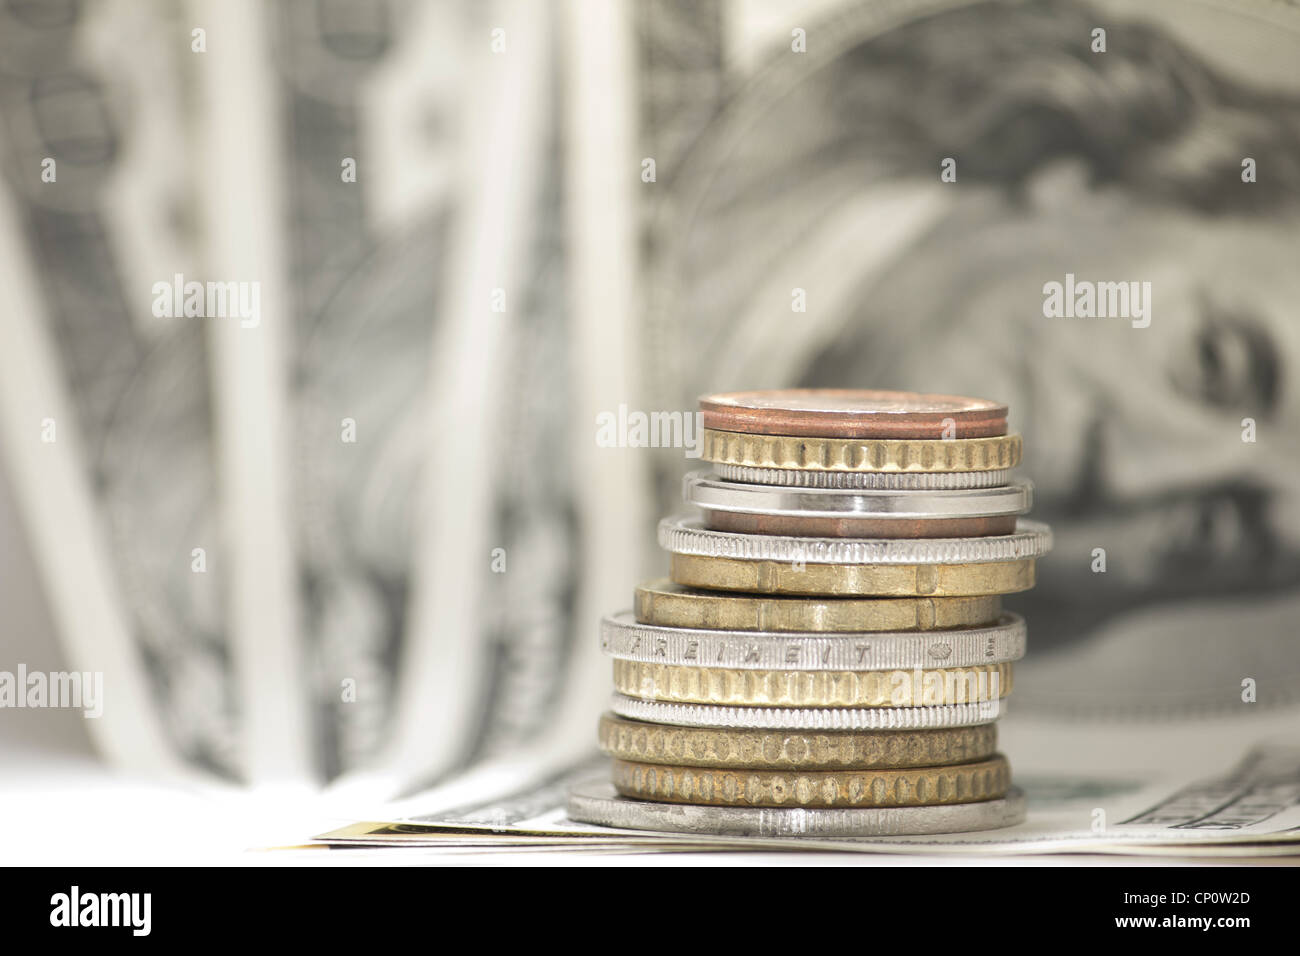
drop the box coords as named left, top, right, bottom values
left=599, top=714, right=997, bottom=771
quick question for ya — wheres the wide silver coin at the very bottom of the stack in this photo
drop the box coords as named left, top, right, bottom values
left=567, top=780, right=1026, bottom=836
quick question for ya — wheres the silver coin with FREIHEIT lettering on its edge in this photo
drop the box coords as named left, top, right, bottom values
left=601, top=611, right=1026, bottom=671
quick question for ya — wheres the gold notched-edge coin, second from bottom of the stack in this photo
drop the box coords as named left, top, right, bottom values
left=614, top=753, right=1011, bottom=808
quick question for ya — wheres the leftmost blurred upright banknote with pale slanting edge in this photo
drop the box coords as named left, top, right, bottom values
left=0, top=3, right=233, bottom=777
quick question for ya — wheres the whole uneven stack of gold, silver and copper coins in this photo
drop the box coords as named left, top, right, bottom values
left=569, top=389, right=1050, bottom=836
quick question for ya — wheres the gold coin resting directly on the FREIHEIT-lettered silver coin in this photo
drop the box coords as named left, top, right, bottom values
left=633, top=579, right=1002, bottom=633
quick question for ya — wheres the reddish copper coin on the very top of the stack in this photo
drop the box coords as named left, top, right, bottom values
left=699, top=389, right=1006, bottom=440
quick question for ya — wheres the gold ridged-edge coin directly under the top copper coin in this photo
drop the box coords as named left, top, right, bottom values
left=701, top=428, right=1022, bottom=472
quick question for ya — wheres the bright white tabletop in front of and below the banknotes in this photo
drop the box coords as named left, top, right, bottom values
left=0, top=749, right=1296, bottom=866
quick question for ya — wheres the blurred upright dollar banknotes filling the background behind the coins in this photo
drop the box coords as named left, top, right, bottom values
left=0, top=0, right=1300, bottom=853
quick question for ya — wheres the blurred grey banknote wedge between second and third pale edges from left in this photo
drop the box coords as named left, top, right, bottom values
left=267, top=3, right=428, bottom=779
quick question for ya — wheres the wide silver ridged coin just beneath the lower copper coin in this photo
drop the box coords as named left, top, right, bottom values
left=659, top=515, right=1052, bottom=564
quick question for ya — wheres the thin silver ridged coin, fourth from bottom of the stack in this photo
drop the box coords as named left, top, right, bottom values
left=610, top=693, right=1006, bottom=730
